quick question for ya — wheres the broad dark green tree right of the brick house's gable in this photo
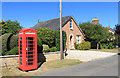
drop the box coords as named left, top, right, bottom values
left=79, top=22, right=113, bottom=49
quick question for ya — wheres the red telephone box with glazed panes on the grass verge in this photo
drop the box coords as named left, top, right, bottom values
left=19, top=28, right=37, bottom=71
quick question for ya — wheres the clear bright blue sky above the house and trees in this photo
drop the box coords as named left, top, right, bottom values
left=2, top=2, right=118, bottom=28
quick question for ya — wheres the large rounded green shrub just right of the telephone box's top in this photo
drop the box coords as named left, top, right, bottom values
left=36, top=27, right=55, bottom=47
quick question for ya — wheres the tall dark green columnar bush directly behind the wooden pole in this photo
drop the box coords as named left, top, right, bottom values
left=55, top=30, right=67, bottom=51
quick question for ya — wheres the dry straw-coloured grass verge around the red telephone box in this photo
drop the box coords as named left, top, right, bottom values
left=2, top=59, right=82, bottom=76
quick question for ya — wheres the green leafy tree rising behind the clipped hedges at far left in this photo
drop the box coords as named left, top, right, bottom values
left=6, top=20, right=22, bottom=34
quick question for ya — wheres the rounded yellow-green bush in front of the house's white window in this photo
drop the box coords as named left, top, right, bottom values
left=77, top=41, right=91, bottom=50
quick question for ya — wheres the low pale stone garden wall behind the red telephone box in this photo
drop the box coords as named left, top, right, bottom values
left=0, top=52, right=60, bottom=66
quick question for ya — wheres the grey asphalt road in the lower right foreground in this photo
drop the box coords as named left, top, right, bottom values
left=38, top=55, right=118, bottom=76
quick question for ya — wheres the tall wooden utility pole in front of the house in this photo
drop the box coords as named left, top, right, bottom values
left=60, top=0, right=64, bottom=60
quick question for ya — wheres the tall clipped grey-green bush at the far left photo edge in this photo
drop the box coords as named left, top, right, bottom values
left=0, top=33, right=12, bottom=55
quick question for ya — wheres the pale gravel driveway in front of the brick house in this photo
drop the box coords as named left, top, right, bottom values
left=66, top=50, right=117, bottom=62
